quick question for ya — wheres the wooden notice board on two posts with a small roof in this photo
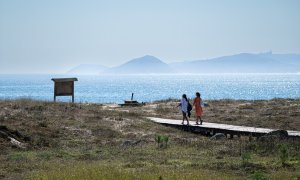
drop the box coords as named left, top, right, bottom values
left=51, top=78, right=78, bottom=102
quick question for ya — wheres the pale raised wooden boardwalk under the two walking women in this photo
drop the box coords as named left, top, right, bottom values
left=148, top=117, right=300, bottom=137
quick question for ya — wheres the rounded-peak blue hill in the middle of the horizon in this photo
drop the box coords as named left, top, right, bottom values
left=104, top=55, right=174, bottom=74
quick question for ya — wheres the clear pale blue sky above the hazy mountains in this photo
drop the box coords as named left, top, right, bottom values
left=0, top=0, right=300, bottom=74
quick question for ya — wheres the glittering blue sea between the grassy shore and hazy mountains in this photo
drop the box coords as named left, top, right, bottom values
left=0, top=74, right=300, bottom=103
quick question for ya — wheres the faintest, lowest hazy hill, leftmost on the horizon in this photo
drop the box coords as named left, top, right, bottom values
left=67, top=64, right=107, bottom=75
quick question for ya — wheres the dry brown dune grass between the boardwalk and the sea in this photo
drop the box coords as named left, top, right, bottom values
left=136, top=99, right=300, bottom=130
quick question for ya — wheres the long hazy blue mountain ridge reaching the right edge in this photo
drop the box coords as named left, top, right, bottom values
left=170, top=53, right=300, bottom=73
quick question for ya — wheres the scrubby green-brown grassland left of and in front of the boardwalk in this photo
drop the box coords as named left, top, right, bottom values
left=0, top=100, right=300, bottom=180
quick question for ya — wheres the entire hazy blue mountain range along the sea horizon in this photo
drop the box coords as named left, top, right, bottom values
left=68, top=52, right=300, bottom=75
